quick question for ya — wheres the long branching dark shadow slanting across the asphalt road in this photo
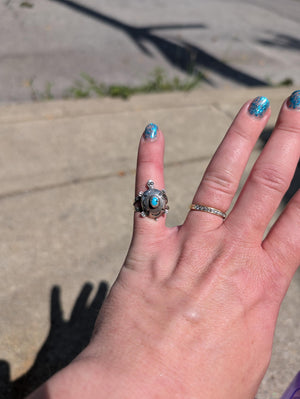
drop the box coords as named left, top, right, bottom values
left=50, top=0, right=268, bottom=86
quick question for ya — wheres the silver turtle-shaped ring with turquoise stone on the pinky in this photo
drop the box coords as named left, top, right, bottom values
left=133, top=180, right=169, bottom=220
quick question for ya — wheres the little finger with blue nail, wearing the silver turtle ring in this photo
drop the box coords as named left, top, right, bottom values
left=134, top=123, right=169, bottom=239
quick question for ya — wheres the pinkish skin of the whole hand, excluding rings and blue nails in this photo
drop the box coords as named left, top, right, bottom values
left=30, top=94, right=300, bottom=399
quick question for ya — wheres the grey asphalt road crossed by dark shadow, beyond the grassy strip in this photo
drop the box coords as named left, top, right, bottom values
left=0, top=0, right=300, bottom=102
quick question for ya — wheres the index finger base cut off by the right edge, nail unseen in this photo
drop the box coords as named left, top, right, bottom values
left=262, top=190, right=300, bottom=283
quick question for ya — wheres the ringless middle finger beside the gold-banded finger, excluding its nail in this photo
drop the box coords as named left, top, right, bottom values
left=227, top=91, right=300, bottom=241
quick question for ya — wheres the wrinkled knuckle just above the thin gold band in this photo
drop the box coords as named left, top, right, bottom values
left=202, top=169, right=236, bottom=196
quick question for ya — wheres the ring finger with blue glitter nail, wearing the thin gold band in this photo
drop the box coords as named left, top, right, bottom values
left=186, top=97, right=270, bottom=228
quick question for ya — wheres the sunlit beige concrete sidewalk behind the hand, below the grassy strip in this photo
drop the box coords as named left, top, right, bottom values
left=0, top=88, right=300, bottom=399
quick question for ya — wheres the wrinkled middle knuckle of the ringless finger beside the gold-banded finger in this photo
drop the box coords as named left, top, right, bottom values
left=251, top=165, right=289, bottom=193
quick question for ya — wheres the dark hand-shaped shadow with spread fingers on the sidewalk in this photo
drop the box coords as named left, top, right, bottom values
left=0, top=282, right=108, bottom=399
